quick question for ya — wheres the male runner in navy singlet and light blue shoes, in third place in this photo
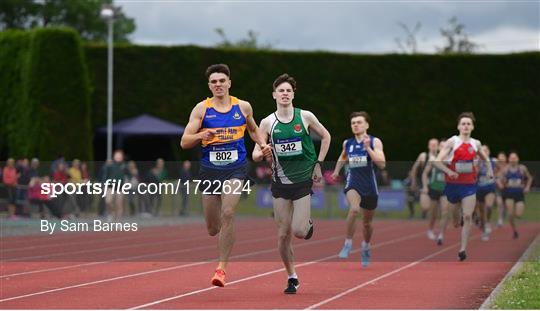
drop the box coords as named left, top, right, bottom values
left=332, top=111, right=386, bottom=267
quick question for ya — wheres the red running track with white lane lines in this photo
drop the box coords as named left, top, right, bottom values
left=0, top=219, right=540, bottom=309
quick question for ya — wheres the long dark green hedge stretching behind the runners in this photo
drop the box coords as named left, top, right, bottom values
left=86, top=45, right=540, bottom=160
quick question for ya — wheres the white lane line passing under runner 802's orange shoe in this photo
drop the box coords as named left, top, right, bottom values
left=129, top=230, right=425, bottom=310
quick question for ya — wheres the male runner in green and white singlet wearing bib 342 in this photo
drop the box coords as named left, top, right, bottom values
left=253, top=73, right=330, bottom=294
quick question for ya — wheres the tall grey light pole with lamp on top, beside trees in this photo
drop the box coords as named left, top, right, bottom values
left=100, top=4, right=114, bottom=160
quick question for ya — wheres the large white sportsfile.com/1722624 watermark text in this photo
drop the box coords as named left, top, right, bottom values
left=41, top=179, right=251, bottom=198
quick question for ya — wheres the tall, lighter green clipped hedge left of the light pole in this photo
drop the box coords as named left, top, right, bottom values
left=0, top=28, right=93, bottom=160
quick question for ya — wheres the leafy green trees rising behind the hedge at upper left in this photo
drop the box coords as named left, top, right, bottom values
left=0, top=0, right=135, bottom=42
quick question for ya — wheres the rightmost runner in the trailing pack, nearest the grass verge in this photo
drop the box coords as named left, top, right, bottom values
left=498, top=152, right=533, bottom=239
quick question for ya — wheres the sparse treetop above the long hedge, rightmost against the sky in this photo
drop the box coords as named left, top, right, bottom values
left=437, top=16, right=480, bottom=54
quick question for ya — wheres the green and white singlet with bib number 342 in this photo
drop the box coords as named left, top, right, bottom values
left=269, top=108, right=317, bottom=184
